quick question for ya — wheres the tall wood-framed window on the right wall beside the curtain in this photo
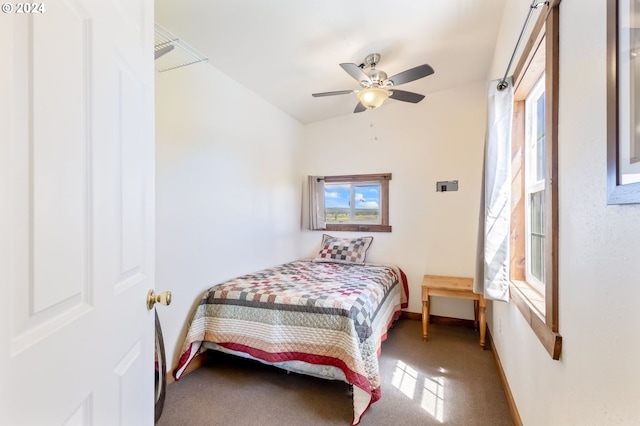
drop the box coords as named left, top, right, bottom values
left=510, top=0, right=562, bottom=359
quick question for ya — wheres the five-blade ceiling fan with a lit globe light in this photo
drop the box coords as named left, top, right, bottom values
left=311, top=53, right=434, bottom=112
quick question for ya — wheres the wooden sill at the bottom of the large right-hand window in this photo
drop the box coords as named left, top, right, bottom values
left=510, top=281, right=562, bottom=360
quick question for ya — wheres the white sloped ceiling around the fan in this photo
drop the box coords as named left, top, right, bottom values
left=155, top=0, right=506, bottom=124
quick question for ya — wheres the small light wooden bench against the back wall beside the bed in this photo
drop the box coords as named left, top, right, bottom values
left=422, top=275, right=487, bottom=349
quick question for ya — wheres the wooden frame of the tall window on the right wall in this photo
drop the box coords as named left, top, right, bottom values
left=510, top=0, right=562, bottom=360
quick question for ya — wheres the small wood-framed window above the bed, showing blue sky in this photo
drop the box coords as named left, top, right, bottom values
left=324, top=173, right=391, bottom=232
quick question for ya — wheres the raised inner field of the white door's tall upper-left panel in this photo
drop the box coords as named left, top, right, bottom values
left=29, top=3, right=91, bottom=313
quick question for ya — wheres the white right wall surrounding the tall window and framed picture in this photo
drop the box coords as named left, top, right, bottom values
left=490, top=0, right=640, bottom=426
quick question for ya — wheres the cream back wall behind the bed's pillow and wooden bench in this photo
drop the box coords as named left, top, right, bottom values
left=301, top=82, right=486, bottom=319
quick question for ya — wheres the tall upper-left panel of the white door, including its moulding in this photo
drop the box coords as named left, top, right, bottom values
left=10, top=2, right=91, bottom=353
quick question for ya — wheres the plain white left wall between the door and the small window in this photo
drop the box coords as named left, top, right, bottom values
left=156, top=64, right=302, bottom=367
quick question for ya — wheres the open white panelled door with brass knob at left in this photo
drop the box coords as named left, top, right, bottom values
left=0, top=0, right=154, bottom=426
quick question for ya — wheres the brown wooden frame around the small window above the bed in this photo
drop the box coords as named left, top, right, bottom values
left=322, top=173, right=391, bottom=232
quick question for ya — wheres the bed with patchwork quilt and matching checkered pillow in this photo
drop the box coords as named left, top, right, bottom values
left=174, top=234, right=408, bottom=425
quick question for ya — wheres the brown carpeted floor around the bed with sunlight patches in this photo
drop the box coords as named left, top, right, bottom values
left=157, top=319, right=513, bottom=426
